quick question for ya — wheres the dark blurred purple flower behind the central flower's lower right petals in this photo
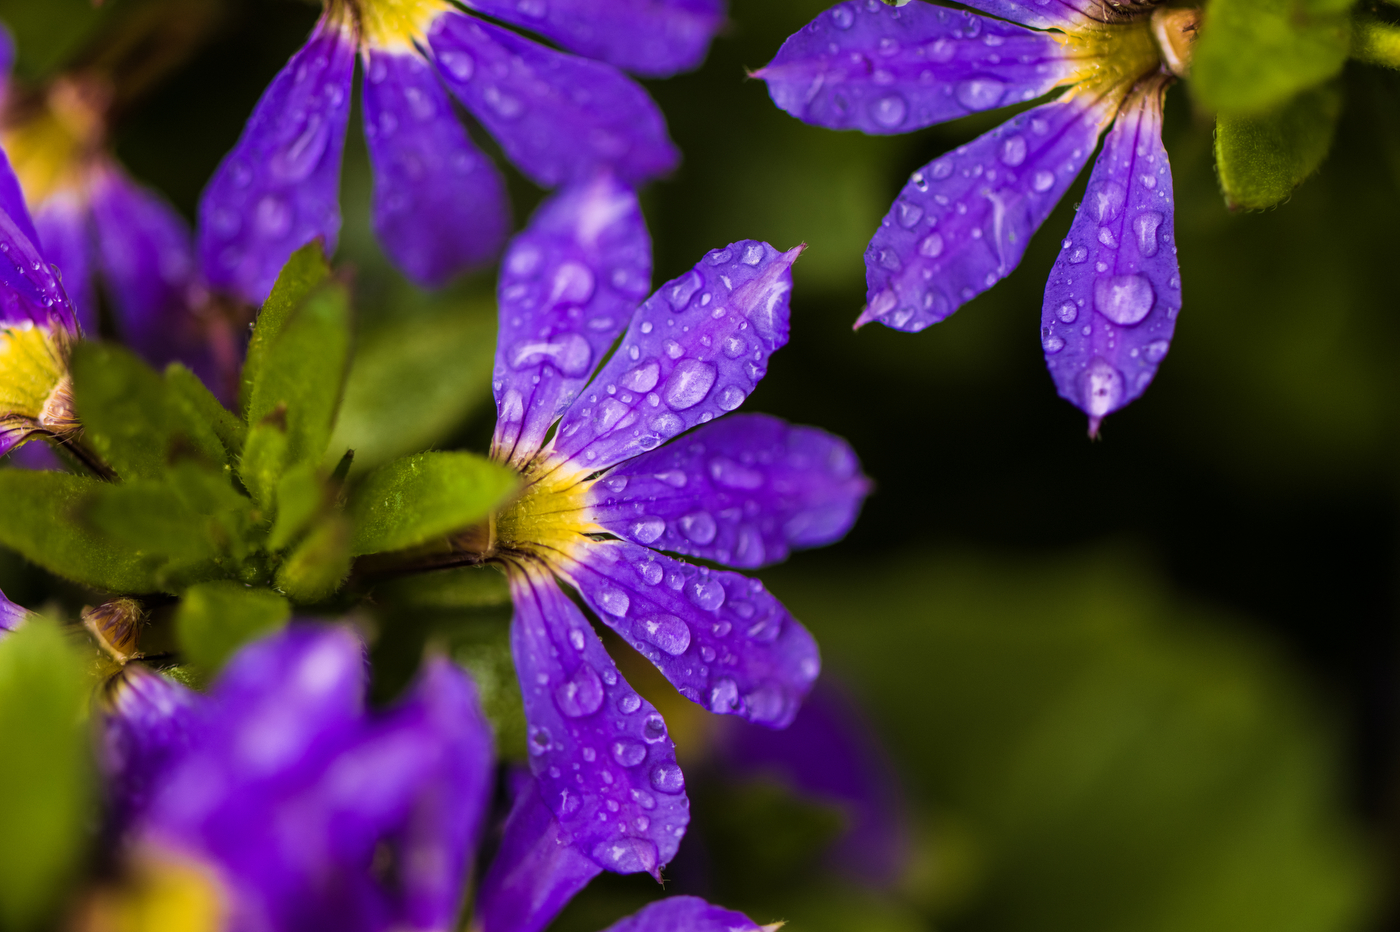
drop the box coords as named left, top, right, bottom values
left=715, top=680, right=909, bottom=887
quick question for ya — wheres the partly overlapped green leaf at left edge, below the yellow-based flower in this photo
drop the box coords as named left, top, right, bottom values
left=0, top=469, right=165, bottom=592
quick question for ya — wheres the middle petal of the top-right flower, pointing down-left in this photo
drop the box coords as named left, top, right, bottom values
left=855, top=85, right=1127, bottom=333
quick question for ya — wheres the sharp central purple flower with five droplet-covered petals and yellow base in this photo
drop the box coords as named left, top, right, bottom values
left=431, top=174, right=869, bottom=876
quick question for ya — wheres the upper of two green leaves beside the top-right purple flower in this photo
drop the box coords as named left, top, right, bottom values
left=1191, top=0, right=1352, bottom=113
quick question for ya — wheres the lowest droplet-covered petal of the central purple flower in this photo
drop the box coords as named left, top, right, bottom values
left=511, top=567, right=690, bottom=880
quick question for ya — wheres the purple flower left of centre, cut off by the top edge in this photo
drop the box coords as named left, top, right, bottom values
left=199, top=0, right=722, bottom=304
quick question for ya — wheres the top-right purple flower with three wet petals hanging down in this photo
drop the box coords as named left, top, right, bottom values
left=757, top=0, right=1196, bottom=435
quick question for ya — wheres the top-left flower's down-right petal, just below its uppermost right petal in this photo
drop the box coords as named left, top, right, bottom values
left=428, top=11, right=680, bottom=188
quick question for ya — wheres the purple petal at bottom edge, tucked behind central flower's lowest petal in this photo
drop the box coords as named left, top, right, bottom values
left=472, top=774, right=602, bottom=932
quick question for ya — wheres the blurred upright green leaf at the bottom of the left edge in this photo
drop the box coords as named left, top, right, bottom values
left=0, top=620, right=95, bottom=929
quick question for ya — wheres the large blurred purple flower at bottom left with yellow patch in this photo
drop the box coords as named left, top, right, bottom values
left=104, top=624, right=493, bottom=932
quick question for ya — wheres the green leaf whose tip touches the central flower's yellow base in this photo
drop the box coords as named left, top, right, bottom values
left=346, top=452, right=519, bottom=556
